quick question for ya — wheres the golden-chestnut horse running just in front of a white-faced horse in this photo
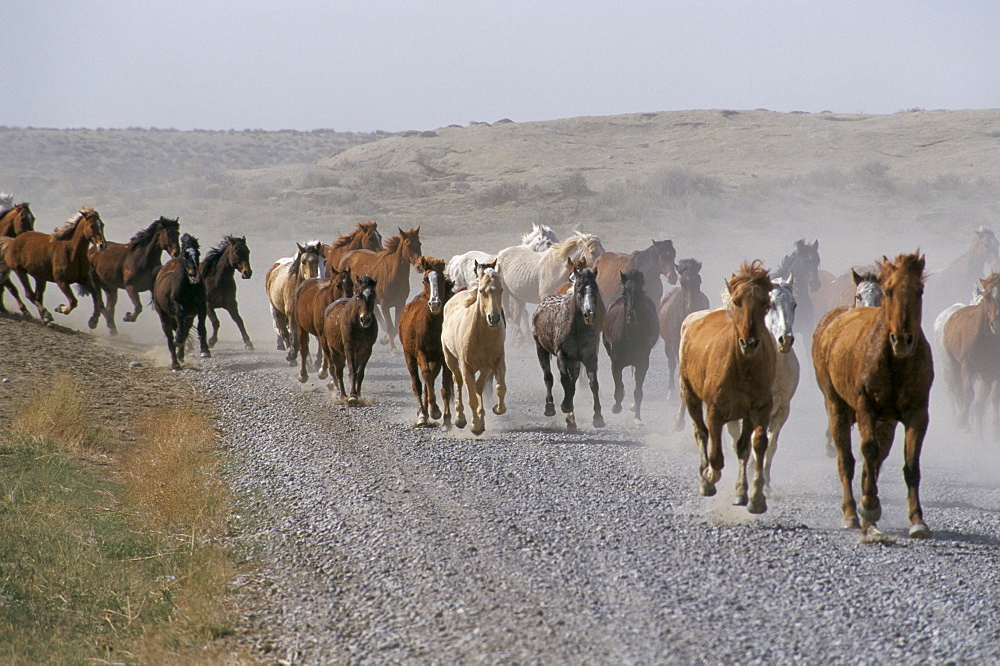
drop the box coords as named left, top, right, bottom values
left=680, top=261, right=777, bottom=513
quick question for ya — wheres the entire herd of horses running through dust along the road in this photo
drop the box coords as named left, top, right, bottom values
left=0, top=195, right=1000, bottom=539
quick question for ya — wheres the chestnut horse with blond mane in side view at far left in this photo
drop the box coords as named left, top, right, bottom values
left=4, top=207, right=107, bottom=323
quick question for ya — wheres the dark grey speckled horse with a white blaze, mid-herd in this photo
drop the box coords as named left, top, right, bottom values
left=531, top=268, right=604, bottom=432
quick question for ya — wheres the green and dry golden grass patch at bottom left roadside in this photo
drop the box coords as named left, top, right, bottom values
left=0, top=377, right=252, bottom=663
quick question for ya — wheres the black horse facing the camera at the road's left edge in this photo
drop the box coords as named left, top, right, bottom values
left=153, top=234, right=212, bottom=370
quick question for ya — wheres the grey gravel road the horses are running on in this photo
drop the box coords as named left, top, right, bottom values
left=191, top=324, right=1000, bottom=663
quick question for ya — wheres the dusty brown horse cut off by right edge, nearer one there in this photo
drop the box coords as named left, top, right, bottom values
left=941, top=273, right=1000, bottom=437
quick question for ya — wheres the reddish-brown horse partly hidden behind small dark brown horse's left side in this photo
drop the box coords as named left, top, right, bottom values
left=288, top=266, right=354, bottom=383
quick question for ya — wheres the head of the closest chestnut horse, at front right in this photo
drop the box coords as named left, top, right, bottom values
left=879, top=251, right=925, bottom=358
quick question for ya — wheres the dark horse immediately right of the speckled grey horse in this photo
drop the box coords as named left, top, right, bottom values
left=601, top=268, right=660, bottom=423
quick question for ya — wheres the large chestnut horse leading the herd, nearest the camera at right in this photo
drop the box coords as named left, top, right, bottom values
left=812, top=253, right=934, bottom=539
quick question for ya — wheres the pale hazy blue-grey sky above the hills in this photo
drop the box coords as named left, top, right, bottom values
left=0, top=0, right=1000, bottom=132
